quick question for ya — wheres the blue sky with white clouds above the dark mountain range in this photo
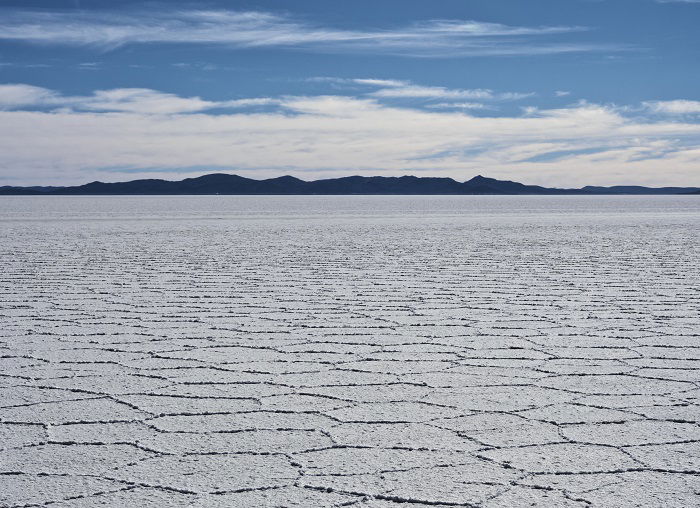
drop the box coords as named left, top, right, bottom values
left=0, top=0, right=700, bottom=187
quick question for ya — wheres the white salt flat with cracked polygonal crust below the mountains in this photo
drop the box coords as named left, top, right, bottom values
left=0, top=196, right=700, bottom=508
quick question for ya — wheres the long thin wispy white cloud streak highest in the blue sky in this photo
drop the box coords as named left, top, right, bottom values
left=0, top=9, right=625, bottom=58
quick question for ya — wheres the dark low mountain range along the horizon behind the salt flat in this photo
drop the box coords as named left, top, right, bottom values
left=0, top=173, right=700, bottom=196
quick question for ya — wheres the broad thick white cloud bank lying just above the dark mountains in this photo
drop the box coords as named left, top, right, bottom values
left=0, top=86, right=700, bottom=186
